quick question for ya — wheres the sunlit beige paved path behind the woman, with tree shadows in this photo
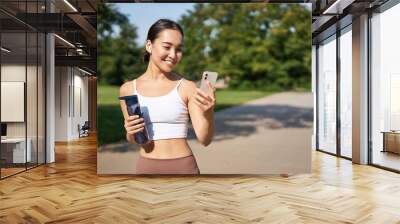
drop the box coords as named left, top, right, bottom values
left=98, top=92, right=313, bottom=174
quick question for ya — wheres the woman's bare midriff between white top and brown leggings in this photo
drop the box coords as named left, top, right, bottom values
left=140, top=138, right=192, bottom=159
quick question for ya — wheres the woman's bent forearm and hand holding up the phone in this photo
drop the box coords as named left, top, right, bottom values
left=186, top=81, right=216, bottom=146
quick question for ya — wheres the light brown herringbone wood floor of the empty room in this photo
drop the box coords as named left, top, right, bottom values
left=0, top=136, right=400, bottom=224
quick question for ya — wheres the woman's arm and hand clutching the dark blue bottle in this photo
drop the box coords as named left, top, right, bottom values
left=119, top=82, right=144, bottom=143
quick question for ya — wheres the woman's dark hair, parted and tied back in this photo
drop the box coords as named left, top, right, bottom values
left=143, top=19, right=183, bottom=62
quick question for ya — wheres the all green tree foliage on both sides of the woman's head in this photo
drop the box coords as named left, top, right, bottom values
left=98, top=3, right=311, bottom=91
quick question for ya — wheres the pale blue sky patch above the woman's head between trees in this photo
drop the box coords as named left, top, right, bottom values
left=116, top=3, right=194, bottom=46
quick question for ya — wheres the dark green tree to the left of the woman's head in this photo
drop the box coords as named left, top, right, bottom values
left=97, top=4, right=144, bottom=85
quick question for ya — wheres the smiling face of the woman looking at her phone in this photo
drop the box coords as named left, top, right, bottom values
left=146, top=29, right=183, bottom=72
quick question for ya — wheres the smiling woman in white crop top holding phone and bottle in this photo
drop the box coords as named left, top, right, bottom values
left=120, top=19, right=215, bottom=174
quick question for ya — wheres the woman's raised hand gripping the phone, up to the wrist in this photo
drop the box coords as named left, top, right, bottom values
left=194, top=81, right=216, bottom=115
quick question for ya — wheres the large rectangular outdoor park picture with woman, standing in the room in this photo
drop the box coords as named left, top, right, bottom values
left=98, top=3, right=313, bottom=174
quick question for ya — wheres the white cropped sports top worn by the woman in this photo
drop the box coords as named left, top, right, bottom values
left=133, top=78, right=189, bottom=140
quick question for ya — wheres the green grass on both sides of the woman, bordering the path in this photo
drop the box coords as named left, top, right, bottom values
left=97, top=85, right=272, bottom=145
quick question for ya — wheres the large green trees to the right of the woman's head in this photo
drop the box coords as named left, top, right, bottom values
left=177, top=3, right=311, bottom=89
